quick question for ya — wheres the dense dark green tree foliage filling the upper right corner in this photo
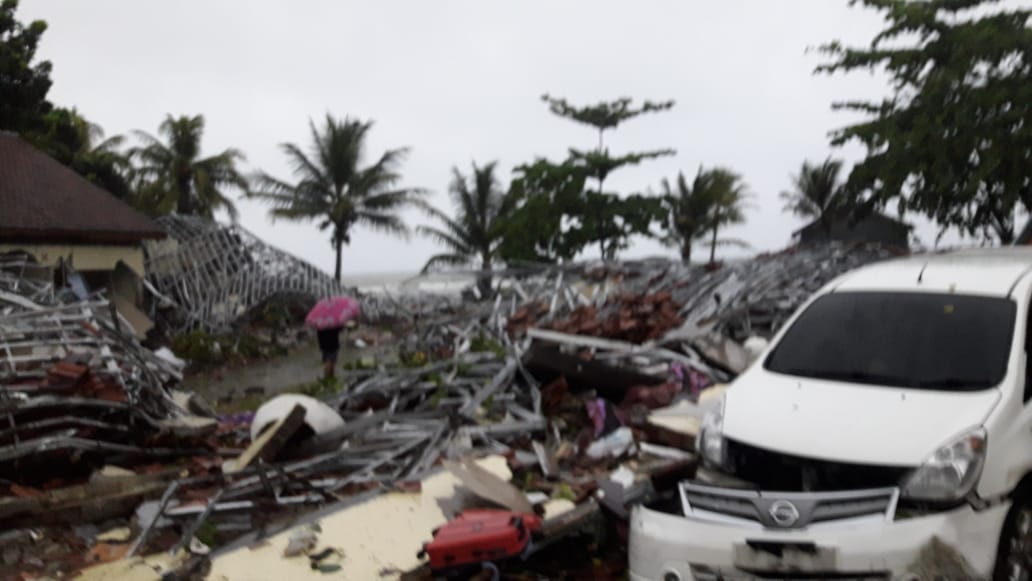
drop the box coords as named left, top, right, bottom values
left=817, top=0, right=1032, bottom=243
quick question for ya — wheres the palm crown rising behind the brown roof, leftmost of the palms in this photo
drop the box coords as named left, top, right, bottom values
left=129, top=115, right=248, bottom=220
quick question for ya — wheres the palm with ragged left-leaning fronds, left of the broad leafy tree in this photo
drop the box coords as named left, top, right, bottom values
left=417, top=161, right=506, bottom=296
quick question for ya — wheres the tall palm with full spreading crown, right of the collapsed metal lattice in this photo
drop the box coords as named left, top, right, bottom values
left=253, top=115, right=424, bottom=281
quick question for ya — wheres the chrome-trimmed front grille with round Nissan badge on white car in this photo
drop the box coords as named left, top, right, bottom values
left=680, top=482, right=899, bottom=529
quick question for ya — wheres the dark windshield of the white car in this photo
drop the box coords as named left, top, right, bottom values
left=765, top=292, right=1017, bottom=391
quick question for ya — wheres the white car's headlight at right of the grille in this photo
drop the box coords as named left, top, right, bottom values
left=903, top=427, right=987, bottom=502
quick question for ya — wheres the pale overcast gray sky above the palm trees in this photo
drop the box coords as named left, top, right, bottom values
left=20, top=0, right=957, bottom=282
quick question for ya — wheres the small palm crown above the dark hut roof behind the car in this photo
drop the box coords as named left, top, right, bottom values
left=781, top=158, right=846, bottom=235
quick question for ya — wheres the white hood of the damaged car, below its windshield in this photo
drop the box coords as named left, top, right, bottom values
left=723, top=368, right=1000, bottom=466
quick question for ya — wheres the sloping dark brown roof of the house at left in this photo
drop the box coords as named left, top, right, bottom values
left=0, top=131, right=165, bottom=244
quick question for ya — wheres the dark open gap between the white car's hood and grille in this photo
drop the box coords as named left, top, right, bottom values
left=724, top=439, right=910, bottom=492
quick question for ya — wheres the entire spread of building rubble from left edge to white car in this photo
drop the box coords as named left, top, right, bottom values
left=0, top=243, right=904, bottom=578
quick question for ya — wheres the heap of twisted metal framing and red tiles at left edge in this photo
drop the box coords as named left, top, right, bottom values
left=0, top=259, right=203, bottom=482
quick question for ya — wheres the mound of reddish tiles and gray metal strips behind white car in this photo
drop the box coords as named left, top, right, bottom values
left=508, top=244, right=893, bottom=343
